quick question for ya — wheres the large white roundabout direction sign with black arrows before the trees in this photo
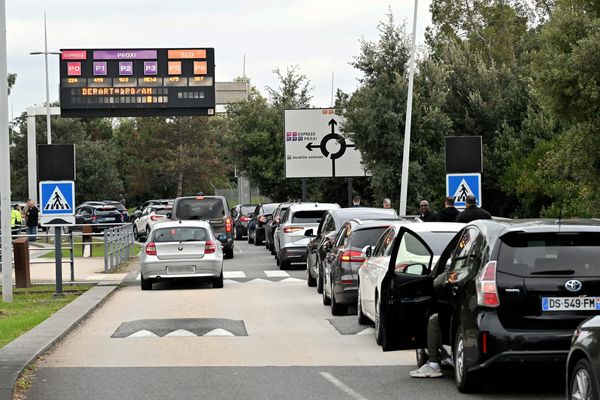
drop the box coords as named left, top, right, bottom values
left=284, top=108, right=370, bottom=178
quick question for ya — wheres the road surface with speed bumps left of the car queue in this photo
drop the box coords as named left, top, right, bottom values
left=27, top=241, right=564, bottom=400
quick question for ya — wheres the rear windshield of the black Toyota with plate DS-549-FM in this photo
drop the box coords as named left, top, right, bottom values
left=498, top=232, right=600, bottom=276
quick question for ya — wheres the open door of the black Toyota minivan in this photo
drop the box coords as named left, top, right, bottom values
left=379, top=227, right=434, bottom=351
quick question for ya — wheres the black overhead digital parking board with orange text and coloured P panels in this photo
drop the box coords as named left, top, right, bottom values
left=60, top=47, right=215, bottom=117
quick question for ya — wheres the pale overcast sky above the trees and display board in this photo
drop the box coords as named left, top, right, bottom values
left=6, top=0, right=431, bottom=117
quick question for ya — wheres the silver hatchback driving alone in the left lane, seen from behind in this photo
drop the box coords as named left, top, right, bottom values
left=140, top=220, right=223, bottom=290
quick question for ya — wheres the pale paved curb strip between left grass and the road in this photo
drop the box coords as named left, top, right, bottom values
left=0, top=282, right=119, bottom=400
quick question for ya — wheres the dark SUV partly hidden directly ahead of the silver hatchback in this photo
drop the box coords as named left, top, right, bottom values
left=171, top=196, right=233, bottom=258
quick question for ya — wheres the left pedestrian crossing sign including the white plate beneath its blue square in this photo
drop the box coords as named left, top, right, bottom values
left=40, top=181, right=75, bottom=226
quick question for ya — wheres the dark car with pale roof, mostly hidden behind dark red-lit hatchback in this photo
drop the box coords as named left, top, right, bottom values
left=305, top=207, right=397, bottom=292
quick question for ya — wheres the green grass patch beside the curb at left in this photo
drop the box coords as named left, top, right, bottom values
left=0, top=285, right=92, bottom=348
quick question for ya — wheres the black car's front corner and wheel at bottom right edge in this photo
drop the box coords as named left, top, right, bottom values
left=567, top=316, right=600, bottom=400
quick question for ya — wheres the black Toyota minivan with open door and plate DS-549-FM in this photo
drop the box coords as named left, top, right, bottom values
left=380, top=220, right=600, bottom=392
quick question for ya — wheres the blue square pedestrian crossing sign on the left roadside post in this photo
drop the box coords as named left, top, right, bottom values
left=40, top=181, right=75, bottom=216
